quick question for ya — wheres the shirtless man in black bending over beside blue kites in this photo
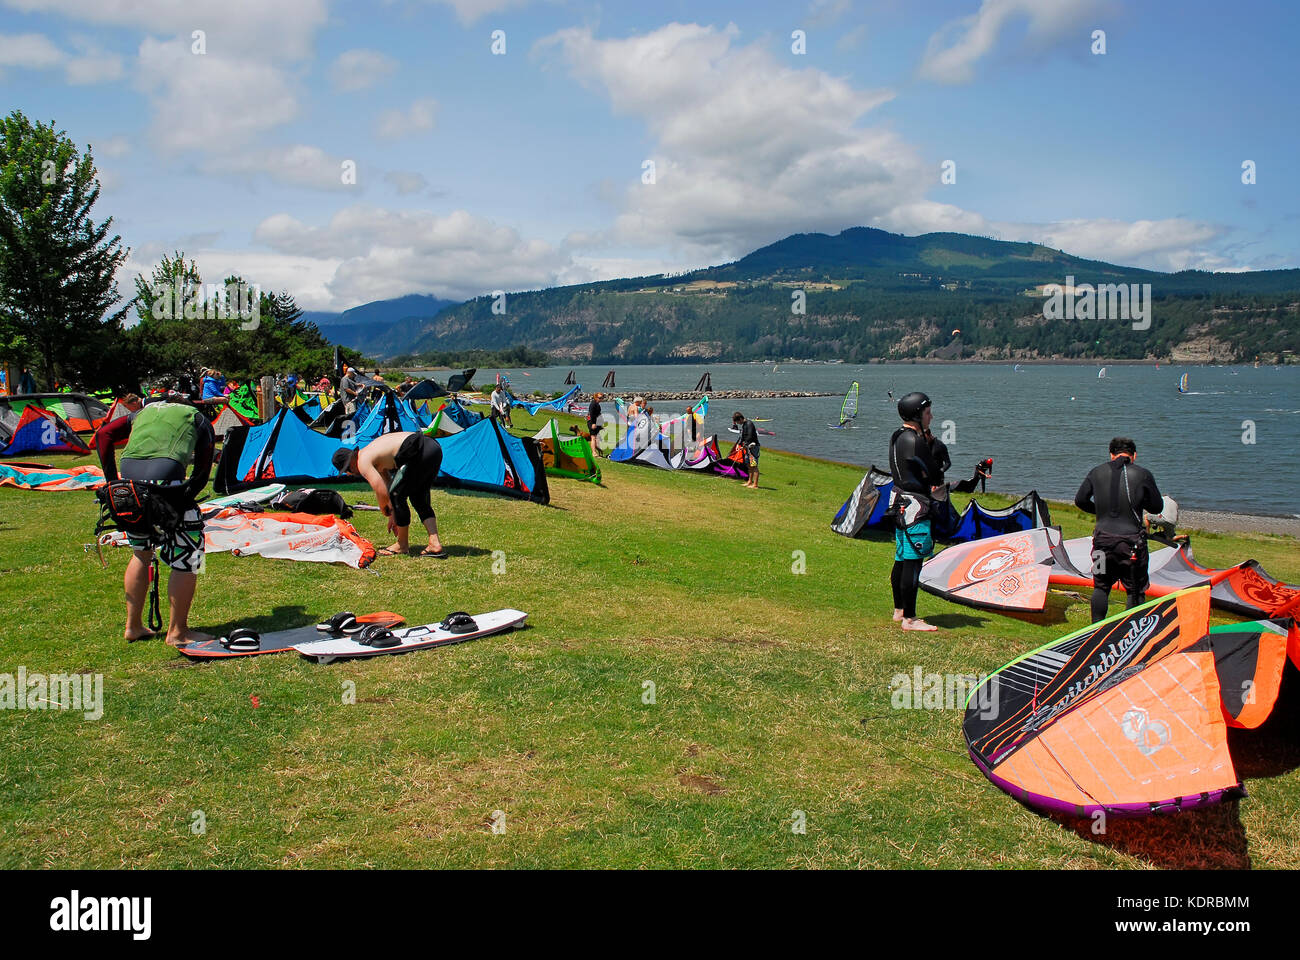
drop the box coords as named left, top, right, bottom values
left=334, top=432, right=447, bottom=559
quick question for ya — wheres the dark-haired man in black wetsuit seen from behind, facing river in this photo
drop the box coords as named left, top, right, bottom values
left=1074, top=437, right=1165, bottom=623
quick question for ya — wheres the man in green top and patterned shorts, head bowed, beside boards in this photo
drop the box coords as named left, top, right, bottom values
left=95, top=392, right=215, bottom=647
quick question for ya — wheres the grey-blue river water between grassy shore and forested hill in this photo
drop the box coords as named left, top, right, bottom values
left=421, top=363, right=1300, bottom=516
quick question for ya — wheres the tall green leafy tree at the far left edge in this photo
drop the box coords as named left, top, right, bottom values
left=0, top=111, right=129, bottom=386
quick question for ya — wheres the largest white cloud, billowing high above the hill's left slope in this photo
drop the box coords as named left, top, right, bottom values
left=540, top=23, right=915, bottom=261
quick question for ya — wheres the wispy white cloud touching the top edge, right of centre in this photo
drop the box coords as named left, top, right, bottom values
left=920, top=0, right=1109, bottom=83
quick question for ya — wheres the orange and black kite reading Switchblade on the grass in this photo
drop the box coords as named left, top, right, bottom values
left=962, top=588, right=1244, bottom=817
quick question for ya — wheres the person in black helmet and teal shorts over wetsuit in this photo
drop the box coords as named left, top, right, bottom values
left=889, top=393, right=943, bottom=631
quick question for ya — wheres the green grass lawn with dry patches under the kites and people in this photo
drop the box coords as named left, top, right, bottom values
left=0, top=415, right=1300, bottom=868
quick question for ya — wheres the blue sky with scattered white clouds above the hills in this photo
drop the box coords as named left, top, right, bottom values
left=0, top=0, right=1300, bottom=310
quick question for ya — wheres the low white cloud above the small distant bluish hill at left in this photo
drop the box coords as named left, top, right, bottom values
left=255, top=206, right=579, bottom=300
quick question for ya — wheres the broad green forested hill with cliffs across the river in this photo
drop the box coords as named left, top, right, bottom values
left=386, top=226, right=1300, bottom=363
